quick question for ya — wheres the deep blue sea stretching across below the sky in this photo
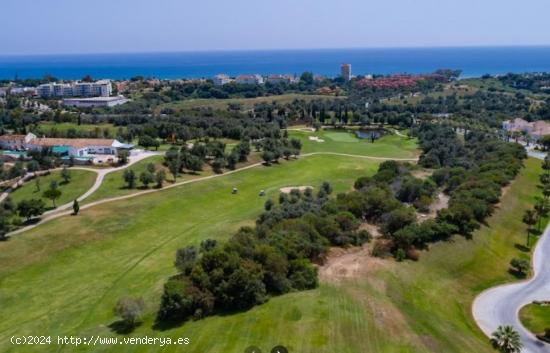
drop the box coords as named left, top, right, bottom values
left=0, top=46, right=550, bottom=79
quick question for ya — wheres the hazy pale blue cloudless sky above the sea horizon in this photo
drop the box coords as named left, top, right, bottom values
left=4, top=0, right=550, bottom=55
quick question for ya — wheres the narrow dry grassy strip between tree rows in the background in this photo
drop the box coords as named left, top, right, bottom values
left=157, top=93, right=345, bottom=112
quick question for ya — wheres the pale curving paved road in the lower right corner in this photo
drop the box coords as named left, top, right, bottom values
left=472, top=225, right=550, bottom=353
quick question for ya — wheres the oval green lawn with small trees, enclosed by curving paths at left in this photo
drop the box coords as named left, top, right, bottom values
left=10, top=169, right=96, bottom=208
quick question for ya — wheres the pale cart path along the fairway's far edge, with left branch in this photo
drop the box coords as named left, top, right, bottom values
left=6, top=152, right=418, bottom=236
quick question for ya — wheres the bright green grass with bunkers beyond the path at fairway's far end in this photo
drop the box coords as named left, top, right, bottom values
left=288, top=130, right=419, bottom=158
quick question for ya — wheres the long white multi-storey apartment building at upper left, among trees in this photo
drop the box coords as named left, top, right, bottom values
left=36, top=80, right=113, bottom=98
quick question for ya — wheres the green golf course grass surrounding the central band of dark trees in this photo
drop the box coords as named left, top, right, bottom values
left=0, top=131, right=541, bottom=353
